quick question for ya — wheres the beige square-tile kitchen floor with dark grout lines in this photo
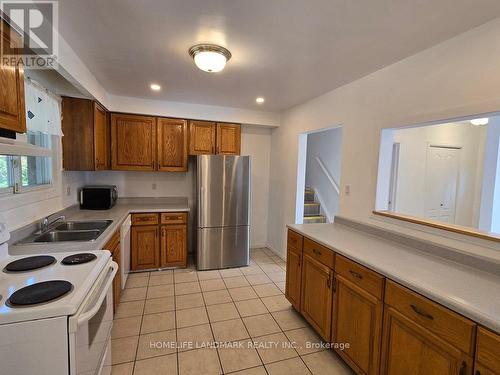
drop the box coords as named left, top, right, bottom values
left=112, top=249, right=352, bottom=375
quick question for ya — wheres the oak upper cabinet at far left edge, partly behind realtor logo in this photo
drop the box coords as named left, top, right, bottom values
left=0, top=20, right=26, bottom=133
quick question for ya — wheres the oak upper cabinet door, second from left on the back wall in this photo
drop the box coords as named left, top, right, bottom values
left=157, top=118, right=188, bottom=172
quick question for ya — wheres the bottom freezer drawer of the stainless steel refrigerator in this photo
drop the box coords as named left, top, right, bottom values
left=197, top=226, right=250, bottom=270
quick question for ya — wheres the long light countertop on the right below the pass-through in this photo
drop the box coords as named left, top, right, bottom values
left=288, top=223, right=500, bottom=333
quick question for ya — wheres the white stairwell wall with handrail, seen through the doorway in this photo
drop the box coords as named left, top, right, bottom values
left=306, top=127, right=342, bottom=222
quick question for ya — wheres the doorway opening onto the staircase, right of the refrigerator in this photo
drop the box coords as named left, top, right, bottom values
left=295, top=126, right=342, bottom=224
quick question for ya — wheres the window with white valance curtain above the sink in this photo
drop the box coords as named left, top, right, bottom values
left=0, top=80, right=61, bottom=194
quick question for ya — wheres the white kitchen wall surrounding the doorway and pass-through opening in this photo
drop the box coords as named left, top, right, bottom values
left=268, top=19, right=500, bottom=254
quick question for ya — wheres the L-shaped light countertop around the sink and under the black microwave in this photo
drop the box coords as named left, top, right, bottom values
left=9, top=197, right=189, bottom=255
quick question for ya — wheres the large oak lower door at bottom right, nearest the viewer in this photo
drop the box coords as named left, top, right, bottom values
left=380, top=305, right=472, bottom=375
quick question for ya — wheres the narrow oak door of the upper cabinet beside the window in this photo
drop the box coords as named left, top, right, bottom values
left=94, top=103, right=111, bottom=171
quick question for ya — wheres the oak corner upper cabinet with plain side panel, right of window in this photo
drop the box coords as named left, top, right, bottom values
left=62, top=97, right=111, bottom=171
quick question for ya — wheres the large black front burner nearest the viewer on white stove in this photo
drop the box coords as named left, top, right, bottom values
left=7, top=280, right=73, bottom=307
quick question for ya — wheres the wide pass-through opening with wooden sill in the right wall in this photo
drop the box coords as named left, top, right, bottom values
left=374, top=115, right=500, bottom=239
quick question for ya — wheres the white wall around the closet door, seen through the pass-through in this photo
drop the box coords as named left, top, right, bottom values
left=388, top=122, right=486, bottom=228
